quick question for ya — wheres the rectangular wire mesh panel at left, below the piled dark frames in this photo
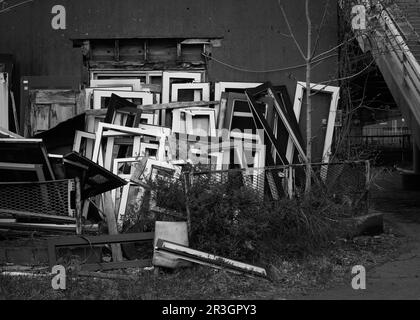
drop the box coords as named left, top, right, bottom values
left=0, top=180, right=75, bottom=217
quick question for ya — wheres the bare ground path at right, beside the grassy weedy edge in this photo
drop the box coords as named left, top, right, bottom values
left=294, top=171, right=420, bottom=300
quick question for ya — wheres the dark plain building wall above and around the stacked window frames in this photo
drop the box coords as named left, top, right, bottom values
left=0, top=0, right=338, bottom=97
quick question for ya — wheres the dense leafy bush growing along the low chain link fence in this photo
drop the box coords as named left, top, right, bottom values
left=121, top=168, right=360, bottom=264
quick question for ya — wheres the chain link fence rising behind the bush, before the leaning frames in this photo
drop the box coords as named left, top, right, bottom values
left=185, top=161, right=371, bottom=215
